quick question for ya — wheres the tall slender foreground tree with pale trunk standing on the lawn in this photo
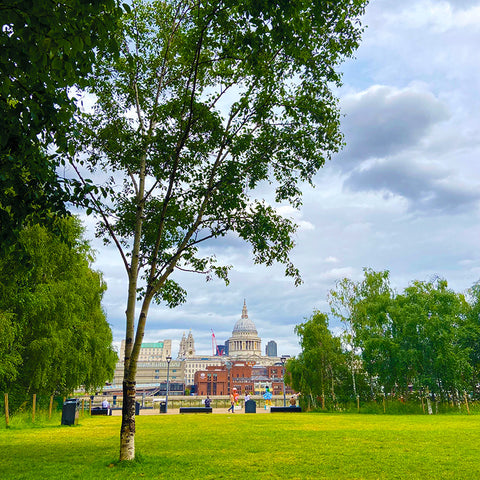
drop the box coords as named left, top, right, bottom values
left=71, top=0, right=367, bottom=460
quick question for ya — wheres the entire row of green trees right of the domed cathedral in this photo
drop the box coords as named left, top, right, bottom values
left=286, top=269, right=480, bottom=408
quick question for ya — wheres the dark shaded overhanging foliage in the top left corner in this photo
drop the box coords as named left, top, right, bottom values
left=0, top=0, right=121, bottom=246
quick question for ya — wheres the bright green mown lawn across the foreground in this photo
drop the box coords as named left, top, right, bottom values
left=0, top=413, right=480, bottom=480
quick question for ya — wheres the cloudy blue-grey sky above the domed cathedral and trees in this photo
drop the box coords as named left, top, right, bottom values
left=85, top=0, right=480, bottom=357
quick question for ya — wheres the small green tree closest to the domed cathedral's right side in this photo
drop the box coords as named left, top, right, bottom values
left=287, top=311, right=345, bottom=410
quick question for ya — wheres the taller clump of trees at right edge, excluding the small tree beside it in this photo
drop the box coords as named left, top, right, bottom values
left=330, top=269, right=479, bottom=395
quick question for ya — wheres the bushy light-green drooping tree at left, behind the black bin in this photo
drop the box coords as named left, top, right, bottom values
left=0, top=217, right=117, bottom=404
